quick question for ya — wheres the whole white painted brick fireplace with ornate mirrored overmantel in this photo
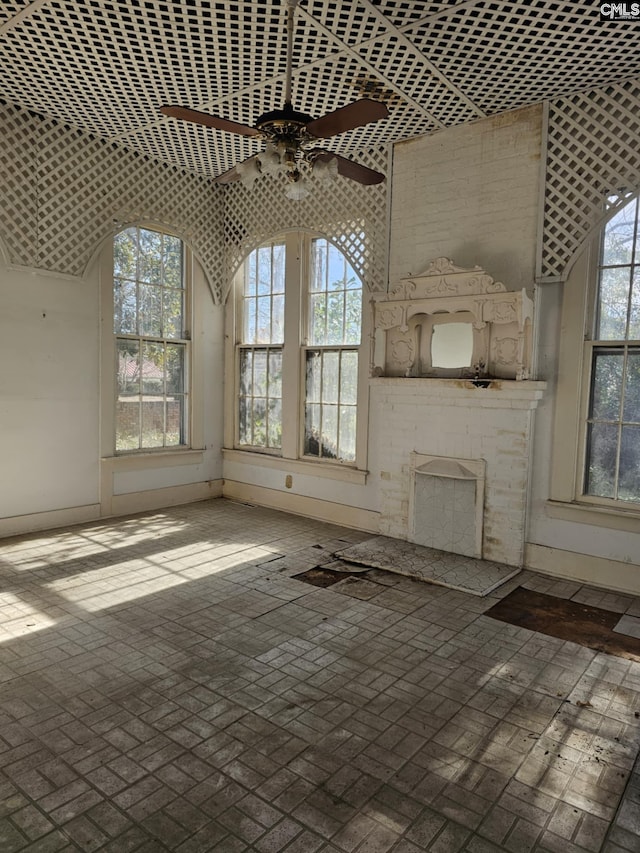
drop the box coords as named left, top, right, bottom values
left=370, top=258, right=546, bottom=566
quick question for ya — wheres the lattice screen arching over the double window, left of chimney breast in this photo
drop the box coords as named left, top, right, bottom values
left=220, top=147, right=389, bottom=291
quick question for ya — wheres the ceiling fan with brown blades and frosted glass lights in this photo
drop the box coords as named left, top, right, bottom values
left=160, top=0, right=389, bottom=198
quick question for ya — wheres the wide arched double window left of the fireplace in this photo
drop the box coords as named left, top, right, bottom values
left=236, top=234, right=362, bottom=464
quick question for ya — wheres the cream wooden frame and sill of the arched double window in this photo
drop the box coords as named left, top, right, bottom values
left=225, top=230, right=370, bottom=472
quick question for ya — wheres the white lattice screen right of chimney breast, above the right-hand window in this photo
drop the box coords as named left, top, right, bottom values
left=540, top=80, right=640, bottom=279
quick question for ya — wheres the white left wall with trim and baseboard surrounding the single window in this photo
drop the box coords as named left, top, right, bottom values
left=0, top=245, right=223, bottom=536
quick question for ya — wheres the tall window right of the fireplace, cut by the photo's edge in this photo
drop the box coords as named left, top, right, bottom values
left=584, top=199, right=640, bottom=502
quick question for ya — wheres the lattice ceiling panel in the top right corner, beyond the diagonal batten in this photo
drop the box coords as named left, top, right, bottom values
left=405, top=0, right=640, bottom=114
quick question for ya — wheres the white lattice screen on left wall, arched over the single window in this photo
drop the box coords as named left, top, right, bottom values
left=0, top=106, right=224, bottom=301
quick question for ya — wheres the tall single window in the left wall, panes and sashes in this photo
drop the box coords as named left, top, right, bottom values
left=113, top=227, right=189, bottom=452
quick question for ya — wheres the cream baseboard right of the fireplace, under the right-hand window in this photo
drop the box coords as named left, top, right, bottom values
left=525, top=543, right=640, bottom=595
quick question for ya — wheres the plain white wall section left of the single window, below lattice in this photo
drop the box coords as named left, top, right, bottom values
left=0, top=261, right=99, bottom=518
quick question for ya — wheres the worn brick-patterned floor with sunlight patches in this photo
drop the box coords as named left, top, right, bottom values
left=0, top=500, right=640, bottom=853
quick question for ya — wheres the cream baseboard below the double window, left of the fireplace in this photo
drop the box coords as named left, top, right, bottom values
left=222, top=479, right=380, bottom=533
